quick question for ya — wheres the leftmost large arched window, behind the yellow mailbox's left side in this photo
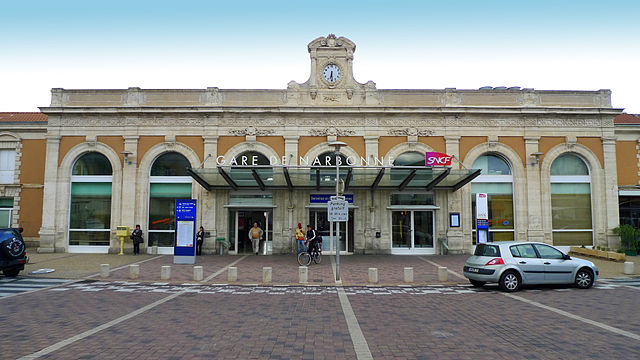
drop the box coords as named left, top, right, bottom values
left=69, top=152, right=113, bottom=246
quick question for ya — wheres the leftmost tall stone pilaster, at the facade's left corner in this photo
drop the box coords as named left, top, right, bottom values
left=38, top=135, right=60, bottom=253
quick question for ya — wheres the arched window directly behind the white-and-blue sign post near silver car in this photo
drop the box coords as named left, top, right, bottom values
left=471, top=154, right=515, bottom=243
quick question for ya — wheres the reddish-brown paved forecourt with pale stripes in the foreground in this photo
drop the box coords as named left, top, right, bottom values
left=0, top=280, right=640, bottom=359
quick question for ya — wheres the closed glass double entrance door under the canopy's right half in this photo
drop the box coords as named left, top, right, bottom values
left=391, top=210, right=435, bottom=254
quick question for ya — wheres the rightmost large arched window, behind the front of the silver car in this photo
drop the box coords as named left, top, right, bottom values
left=551, top=153, right=593, bottom=246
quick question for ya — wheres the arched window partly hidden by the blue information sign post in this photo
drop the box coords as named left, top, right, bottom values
left=148, top=152, right=191, bottom=247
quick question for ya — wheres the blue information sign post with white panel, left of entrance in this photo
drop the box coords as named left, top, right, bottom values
left=173, top=199, right=197, bottom=264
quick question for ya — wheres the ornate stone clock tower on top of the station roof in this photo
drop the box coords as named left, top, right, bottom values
left=287, top=34, right=379, bottom=105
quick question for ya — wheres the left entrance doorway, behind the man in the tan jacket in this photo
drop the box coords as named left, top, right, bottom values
left=229, top=209, right=273, bottom=255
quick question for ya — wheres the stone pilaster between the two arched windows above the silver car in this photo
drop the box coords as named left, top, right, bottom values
left=524, top=136, right=548, bottom=242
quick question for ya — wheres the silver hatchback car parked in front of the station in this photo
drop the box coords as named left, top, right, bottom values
left=463, top=241, right=598, bottom=292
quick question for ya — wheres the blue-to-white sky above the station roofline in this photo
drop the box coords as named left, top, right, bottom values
left=0, top=0, right=640, bottom=114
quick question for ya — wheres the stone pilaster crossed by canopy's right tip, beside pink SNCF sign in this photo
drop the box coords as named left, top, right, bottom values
left=448, top=136, right=462, bottom=254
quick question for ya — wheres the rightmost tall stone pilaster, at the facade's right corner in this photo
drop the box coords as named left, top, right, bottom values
left=604, top=137, right=620, bottom=248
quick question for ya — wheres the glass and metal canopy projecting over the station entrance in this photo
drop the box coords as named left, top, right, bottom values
left=187, top=165, right=480, bottom=191
